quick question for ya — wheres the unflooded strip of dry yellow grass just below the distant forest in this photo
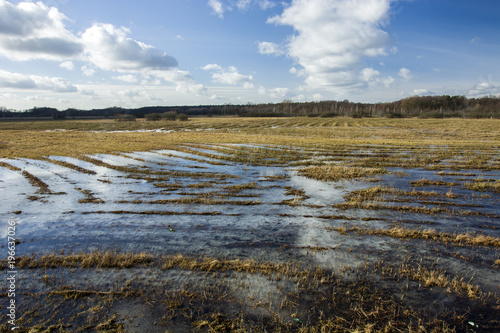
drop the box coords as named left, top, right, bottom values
left=0, top=118, right=500, bottom=158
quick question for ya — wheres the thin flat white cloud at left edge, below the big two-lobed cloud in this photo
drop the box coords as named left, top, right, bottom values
left=0, top=70, right=78, bottom=92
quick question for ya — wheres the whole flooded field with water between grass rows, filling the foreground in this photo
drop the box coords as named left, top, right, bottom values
left=0, top=120, right=500, bottom=332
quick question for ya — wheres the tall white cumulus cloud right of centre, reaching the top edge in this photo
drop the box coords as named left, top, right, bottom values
left=268, top=0, right=390, bottom=90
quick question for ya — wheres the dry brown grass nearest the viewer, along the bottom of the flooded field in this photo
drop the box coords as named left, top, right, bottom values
left=0, top=248, right=492, bottom=333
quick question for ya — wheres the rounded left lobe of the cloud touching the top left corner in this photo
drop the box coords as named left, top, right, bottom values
left=0, top=0, right=83, bottom=61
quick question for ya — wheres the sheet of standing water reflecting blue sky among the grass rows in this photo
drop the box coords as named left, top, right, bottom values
left=0, top=145, right=500, bottom=331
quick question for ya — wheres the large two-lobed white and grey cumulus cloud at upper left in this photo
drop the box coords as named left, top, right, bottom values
left=0, top=0, right=177, bottom=71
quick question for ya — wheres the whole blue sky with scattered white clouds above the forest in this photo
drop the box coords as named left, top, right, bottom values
left=0, top=0, right=500, bottom=110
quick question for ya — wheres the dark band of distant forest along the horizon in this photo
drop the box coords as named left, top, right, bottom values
left=0, top=96, right=500, bottom=120
